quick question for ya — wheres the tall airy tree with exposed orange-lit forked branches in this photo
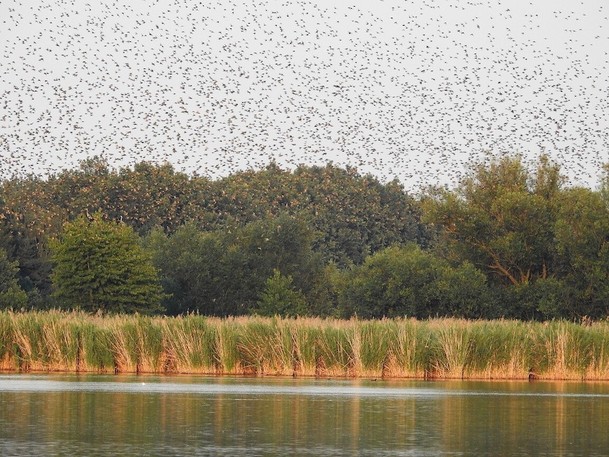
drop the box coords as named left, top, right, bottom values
left=424, top=156, right=563, bottom=286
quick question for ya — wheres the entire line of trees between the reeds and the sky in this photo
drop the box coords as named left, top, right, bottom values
left=0, top=156, right=609, bottom=320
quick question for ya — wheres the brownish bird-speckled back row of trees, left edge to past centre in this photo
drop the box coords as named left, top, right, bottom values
left=0, top=157, right=425, bottom=302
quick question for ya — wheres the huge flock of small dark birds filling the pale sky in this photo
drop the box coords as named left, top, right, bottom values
left=0, top=0, right=609, bottom=189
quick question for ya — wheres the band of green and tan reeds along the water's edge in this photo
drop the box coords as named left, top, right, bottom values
left=0, top=311, right=609, bottom=380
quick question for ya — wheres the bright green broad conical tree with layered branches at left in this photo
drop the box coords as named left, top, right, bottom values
left=51, top=213, right=163, bottom=314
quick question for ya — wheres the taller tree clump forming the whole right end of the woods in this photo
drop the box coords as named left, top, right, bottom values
left=424, top=156, right=609, bottom=319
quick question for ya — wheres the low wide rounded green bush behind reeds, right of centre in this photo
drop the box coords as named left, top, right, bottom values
left=336, top=245, right=490, bottom=318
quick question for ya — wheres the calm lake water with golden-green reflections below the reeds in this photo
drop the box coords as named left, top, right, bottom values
left=0, top=375, right=609, bottom=456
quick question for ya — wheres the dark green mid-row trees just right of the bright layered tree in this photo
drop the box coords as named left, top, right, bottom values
left=148, top=214, right=323, bottom=316
